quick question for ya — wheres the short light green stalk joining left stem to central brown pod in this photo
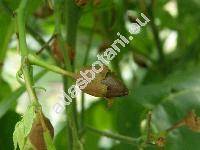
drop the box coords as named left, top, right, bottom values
left=28, top=54, right=75, bottom=78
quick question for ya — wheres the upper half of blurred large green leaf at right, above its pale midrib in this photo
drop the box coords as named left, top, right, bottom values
left=133, top=65, right=200, bottom=109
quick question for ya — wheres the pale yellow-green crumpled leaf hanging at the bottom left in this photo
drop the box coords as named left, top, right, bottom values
left=13, top=104, right=36, bottom=149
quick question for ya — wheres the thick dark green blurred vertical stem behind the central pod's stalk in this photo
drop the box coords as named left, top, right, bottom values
left=64, top=0, right=82, bottom=150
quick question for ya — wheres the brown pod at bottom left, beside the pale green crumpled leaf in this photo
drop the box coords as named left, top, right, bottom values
left=29, top=114, right=54, bottom=150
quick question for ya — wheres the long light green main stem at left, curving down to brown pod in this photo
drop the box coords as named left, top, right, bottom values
left=17, top=0, right=54, bottom=147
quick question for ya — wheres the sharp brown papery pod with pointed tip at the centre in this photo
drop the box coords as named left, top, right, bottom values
left=76, top=66, right=128, bottom=98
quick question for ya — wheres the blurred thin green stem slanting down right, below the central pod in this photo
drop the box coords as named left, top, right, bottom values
left=86, top=126, right=141, bottom=145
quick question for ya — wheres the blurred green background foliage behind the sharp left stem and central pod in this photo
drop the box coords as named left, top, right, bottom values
left=0, top=0, right=200, bottom=150
